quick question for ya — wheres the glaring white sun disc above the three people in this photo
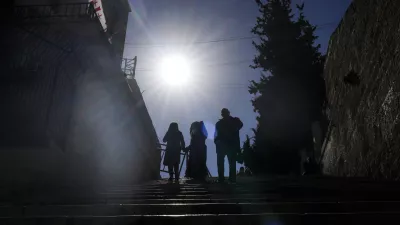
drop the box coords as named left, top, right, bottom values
left=161, top=55, right=190, bottom=85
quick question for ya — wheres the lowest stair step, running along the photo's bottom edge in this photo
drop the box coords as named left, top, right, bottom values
left=0, top=213, right=400, bottom=225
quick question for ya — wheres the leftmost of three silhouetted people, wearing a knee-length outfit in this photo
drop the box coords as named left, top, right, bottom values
left=163, top=123, right=185, bottom=181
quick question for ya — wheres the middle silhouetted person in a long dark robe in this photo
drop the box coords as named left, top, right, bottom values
left=186, top=121, right=208, bottom=180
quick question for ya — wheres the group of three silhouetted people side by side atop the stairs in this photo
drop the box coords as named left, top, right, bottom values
left=163, top=108, right=243, bottom=182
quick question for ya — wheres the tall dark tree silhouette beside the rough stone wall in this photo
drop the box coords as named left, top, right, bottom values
left=244, top=0, right=325, bottom=173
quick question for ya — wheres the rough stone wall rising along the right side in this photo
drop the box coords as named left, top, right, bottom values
left=323, top=0, right=400, bottom=179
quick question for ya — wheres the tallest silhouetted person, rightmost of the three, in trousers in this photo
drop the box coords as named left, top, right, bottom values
left=214, top=108, right=243, bottom=182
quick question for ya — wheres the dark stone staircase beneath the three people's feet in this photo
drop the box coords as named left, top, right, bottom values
left=0, top=178, right=400, bottom=225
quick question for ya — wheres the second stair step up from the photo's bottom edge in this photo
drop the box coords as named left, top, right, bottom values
left=0, top=202, right=400, bottom=217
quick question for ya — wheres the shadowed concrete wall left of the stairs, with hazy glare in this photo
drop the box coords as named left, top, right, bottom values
left=0, top=2, right=159, bottom=192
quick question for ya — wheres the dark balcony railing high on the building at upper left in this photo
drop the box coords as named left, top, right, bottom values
left=14, top=3, right=97, bottom=19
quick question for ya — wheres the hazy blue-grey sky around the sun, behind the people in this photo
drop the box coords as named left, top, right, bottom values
left=125, top=0, right=351, bottom=176
